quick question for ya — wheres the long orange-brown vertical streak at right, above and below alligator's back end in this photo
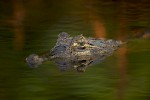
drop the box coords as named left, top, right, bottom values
left=117, top=1, right=128, bottom=100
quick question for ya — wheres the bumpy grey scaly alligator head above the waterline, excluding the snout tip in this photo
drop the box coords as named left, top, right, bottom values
left=51, top=32, right=122, bottom=59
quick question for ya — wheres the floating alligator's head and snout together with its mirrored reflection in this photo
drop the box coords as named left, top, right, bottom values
left=26, top=32, right=126, bottom=72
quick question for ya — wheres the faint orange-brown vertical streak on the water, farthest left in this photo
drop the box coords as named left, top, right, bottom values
left=12, top=0, right=25, bottom=50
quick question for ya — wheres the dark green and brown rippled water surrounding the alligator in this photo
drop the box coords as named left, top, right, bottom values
left=0, top=0, right=150, bottom=100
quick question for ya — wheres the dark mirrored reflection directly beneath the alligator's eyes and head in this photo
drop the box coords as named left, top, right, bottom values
left=54, top=54, right=110, bottom=72
